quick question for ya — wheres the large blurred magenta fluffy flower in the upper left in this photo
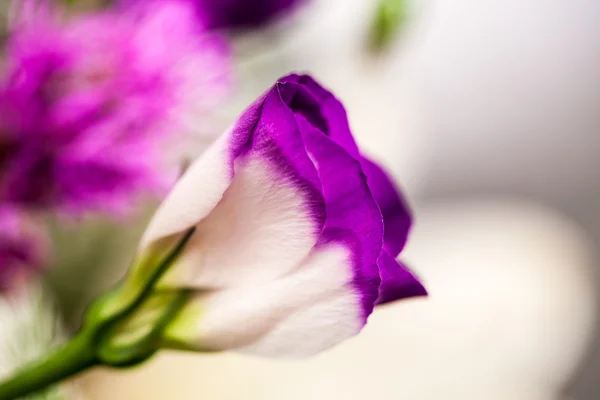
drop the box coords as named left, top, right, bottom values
left=0, top=0, right=228, bottom=213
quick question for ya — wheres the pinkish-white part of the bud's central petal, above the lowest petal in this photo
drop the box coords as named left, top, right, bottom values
left=155, top=153, right=321, bottom=289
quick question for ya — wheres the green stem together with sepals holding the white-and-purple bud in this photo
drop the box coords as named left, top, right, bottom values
left=0, top=229, right=194, bottom=400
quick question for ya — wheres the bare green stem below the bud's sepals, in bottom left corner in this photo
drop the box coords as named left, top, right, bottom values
left=0, top=332, right=98, bottom=400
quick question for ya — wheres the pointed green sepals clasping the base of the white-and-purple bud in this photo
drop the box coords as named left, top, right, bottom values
left=84, top=228, right=195, bottom=367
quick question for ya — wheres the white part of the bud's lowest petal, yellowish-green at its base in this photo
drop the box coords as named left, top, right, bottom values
left=166, top=245, right=364, bottom=357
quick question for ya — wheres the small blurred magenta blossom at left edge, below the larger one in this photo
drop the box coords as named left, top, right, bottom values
left=0, top=206, right=45, bottom=292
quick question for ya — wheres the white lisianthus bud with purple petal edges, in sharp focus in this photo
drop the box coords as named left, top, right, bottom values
left=131, top=75, right=426, bottom=356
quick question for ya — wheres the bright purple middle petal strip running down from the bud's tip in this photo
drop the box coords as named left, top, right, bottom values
left=280, top=81, right=383, bottom=321
